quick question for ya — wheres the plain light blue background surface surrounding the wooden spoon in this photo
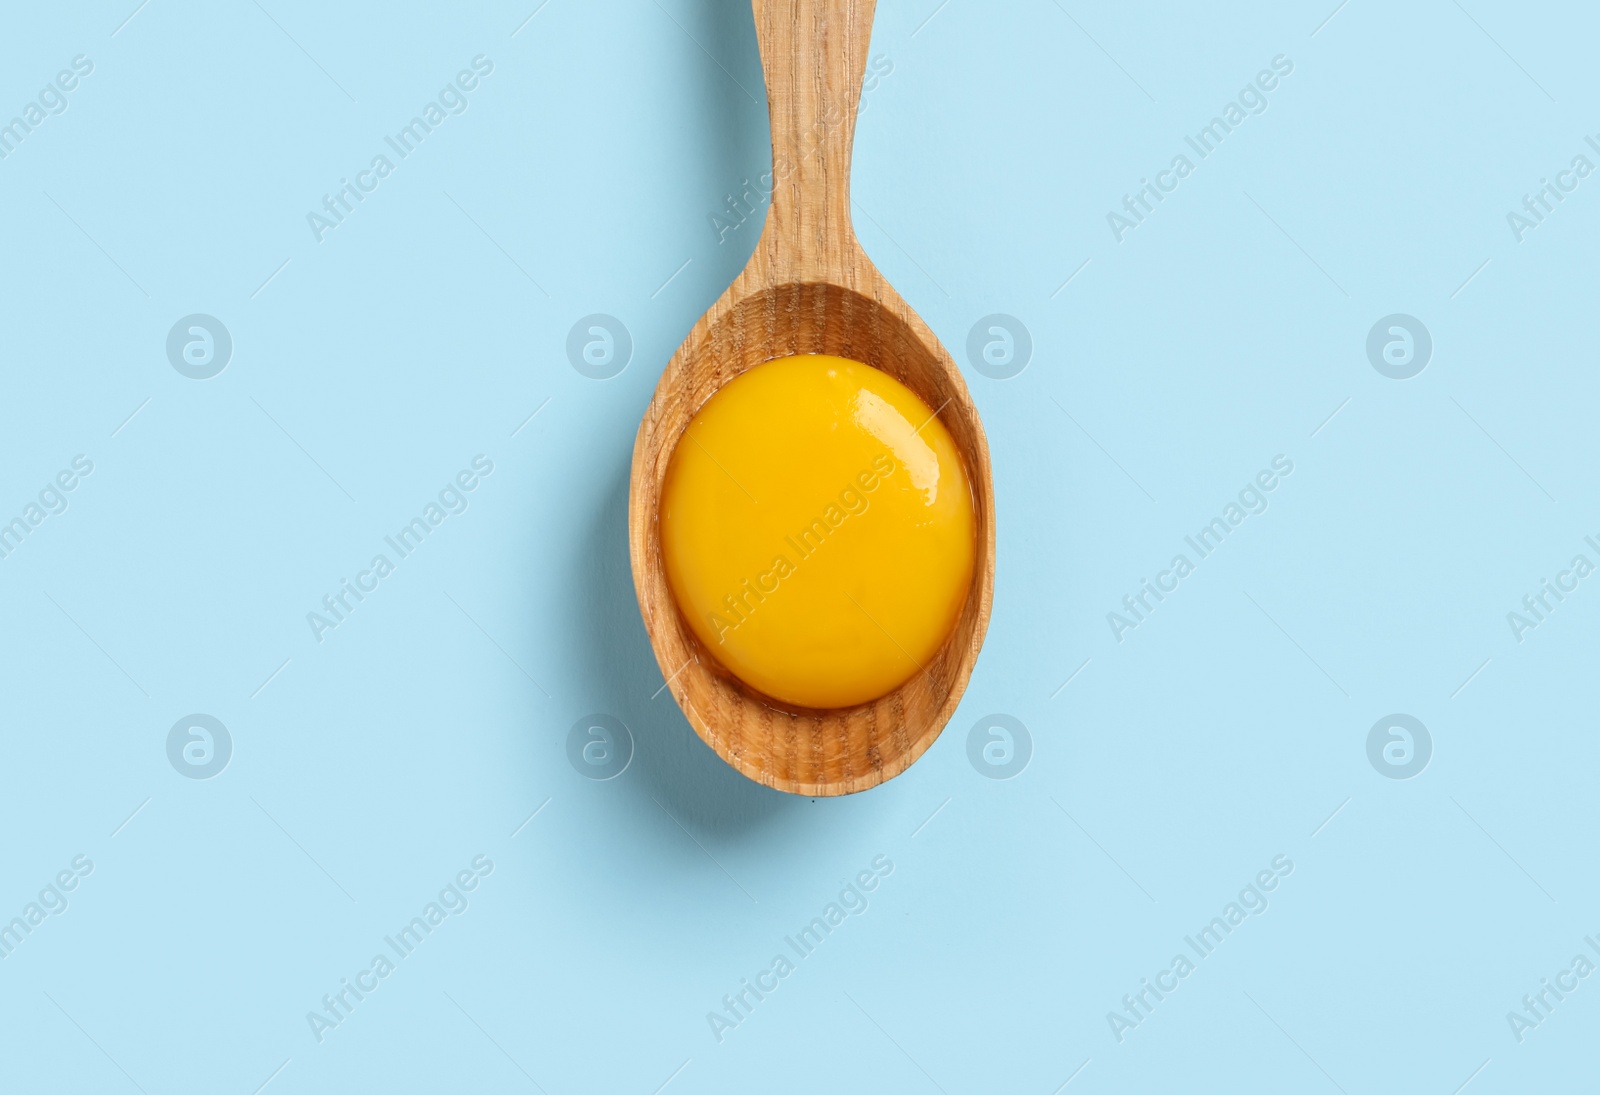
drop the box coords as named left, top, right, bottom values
left=0, top=0, right=1600, bottom=1095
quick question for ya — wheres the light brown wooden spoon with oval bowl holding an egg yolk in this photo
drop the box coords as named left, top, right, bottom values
left=627, top=0, right=995, bottom=796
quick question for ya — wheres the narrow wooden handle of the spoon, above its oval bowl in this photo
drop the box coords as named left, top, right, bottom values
left=752, top=0, right=877, bottom=283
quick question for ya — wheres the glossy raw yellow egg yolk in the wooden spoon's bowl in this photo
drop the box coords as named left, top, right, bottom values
left=661, top=354, right=976, bottom=708
